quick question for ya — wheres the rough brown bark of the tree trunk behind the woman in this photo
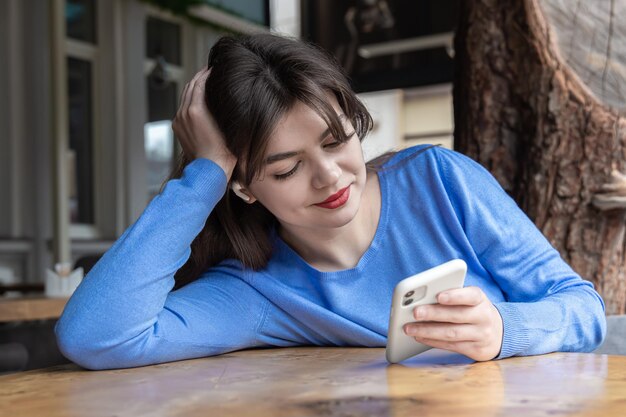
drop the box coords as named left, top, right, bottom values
left=454, top=0, right=626, bottom=314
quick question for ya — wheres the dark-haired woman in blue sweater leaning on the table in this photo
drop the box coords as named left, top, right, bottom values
left=56, top=35, right=605, bottom=369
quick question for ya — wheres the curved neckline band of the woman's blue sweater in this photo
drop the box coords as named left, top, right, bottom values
left=274, top=167, right=389, bottom=278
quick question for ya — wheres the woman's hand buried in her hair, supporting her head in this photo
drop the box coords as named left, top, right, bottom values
left=172, top=67, right=237, bottom=181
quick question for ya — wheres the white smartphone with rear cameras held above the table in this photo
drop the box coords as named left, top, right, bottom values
left=385, top=259, right=467, bottom=363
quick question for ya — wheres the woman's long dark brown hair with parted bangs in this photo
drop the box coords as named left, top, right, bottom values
left=170, top=34, right=380, bottom=288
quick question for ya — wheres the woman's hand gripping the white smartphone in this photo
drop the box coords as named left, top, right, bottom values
left=404, top=287, right=503, bottom=361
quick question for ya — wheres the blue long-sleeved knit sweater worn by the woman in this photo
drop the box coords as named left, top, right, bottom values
left=56, top=148, right=606, bottom=369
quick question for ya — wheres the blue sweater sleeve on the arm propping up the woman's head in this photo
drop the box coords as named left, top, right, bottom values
left=55, top=159, right=266, bottom=369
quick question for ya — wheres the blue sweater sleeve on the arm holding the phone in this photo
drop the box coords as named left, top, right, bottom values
left=437, top=150, right=606, bottom=358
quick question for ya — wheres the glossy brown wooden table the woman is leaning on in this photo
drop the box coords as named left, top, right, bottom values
left=0, top=347, right=626, bottom=417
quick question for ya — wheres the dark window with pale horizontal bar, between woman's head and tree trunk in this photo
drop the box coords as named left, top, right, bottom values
left=301, top=0, right=459, bottom=92
